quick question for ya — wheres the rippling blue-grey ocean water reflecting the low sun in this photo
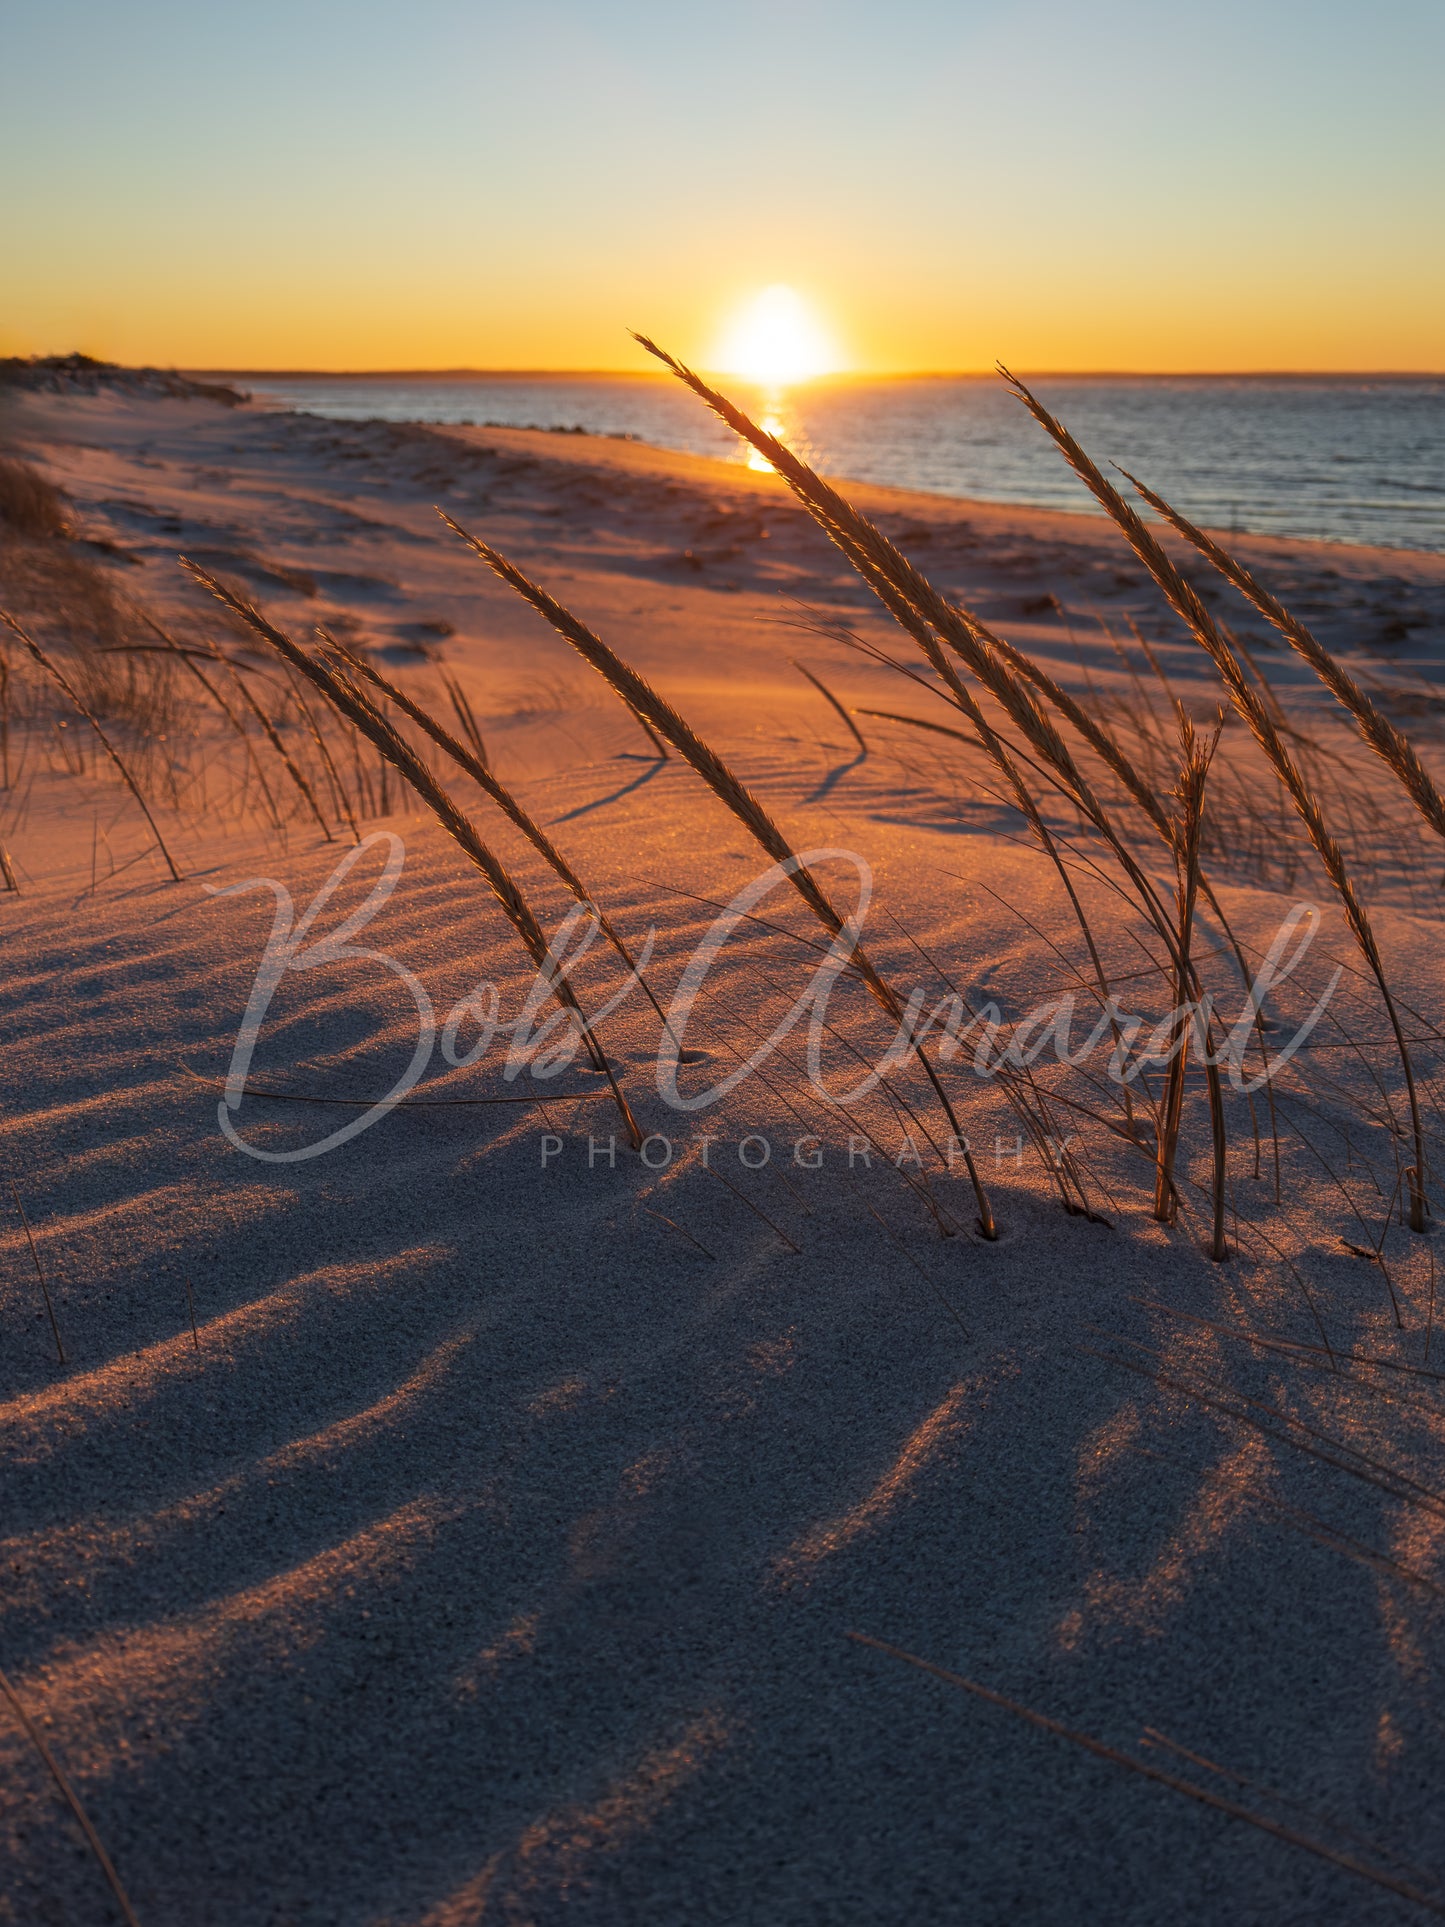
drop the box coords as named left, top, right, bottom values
left=241, top=374, right=1445, bottom=551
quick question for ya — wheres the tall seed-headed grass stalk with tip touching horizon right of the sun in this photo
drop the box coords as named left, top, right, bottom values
left=1000, top=368, right=1428, bottom=1231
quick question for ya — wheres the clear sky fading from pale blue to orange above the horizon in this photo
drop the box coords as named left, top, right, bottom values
left=0, top=0, right=1445, bottom=374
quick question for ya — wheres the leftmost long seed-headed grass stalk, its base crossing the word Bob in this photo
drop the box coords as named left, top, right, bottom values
left=181, top=557, right=642, bottom=1150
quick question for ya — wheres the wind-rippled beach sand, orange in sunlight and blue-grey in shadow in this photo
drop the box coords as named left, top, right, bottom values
left=0, top=379, right=1445, bottom=1927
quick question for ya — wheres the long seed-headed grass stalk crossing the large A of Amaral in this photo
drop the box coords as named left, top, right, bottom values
left=437, top=509, right=998, bottom=1239
